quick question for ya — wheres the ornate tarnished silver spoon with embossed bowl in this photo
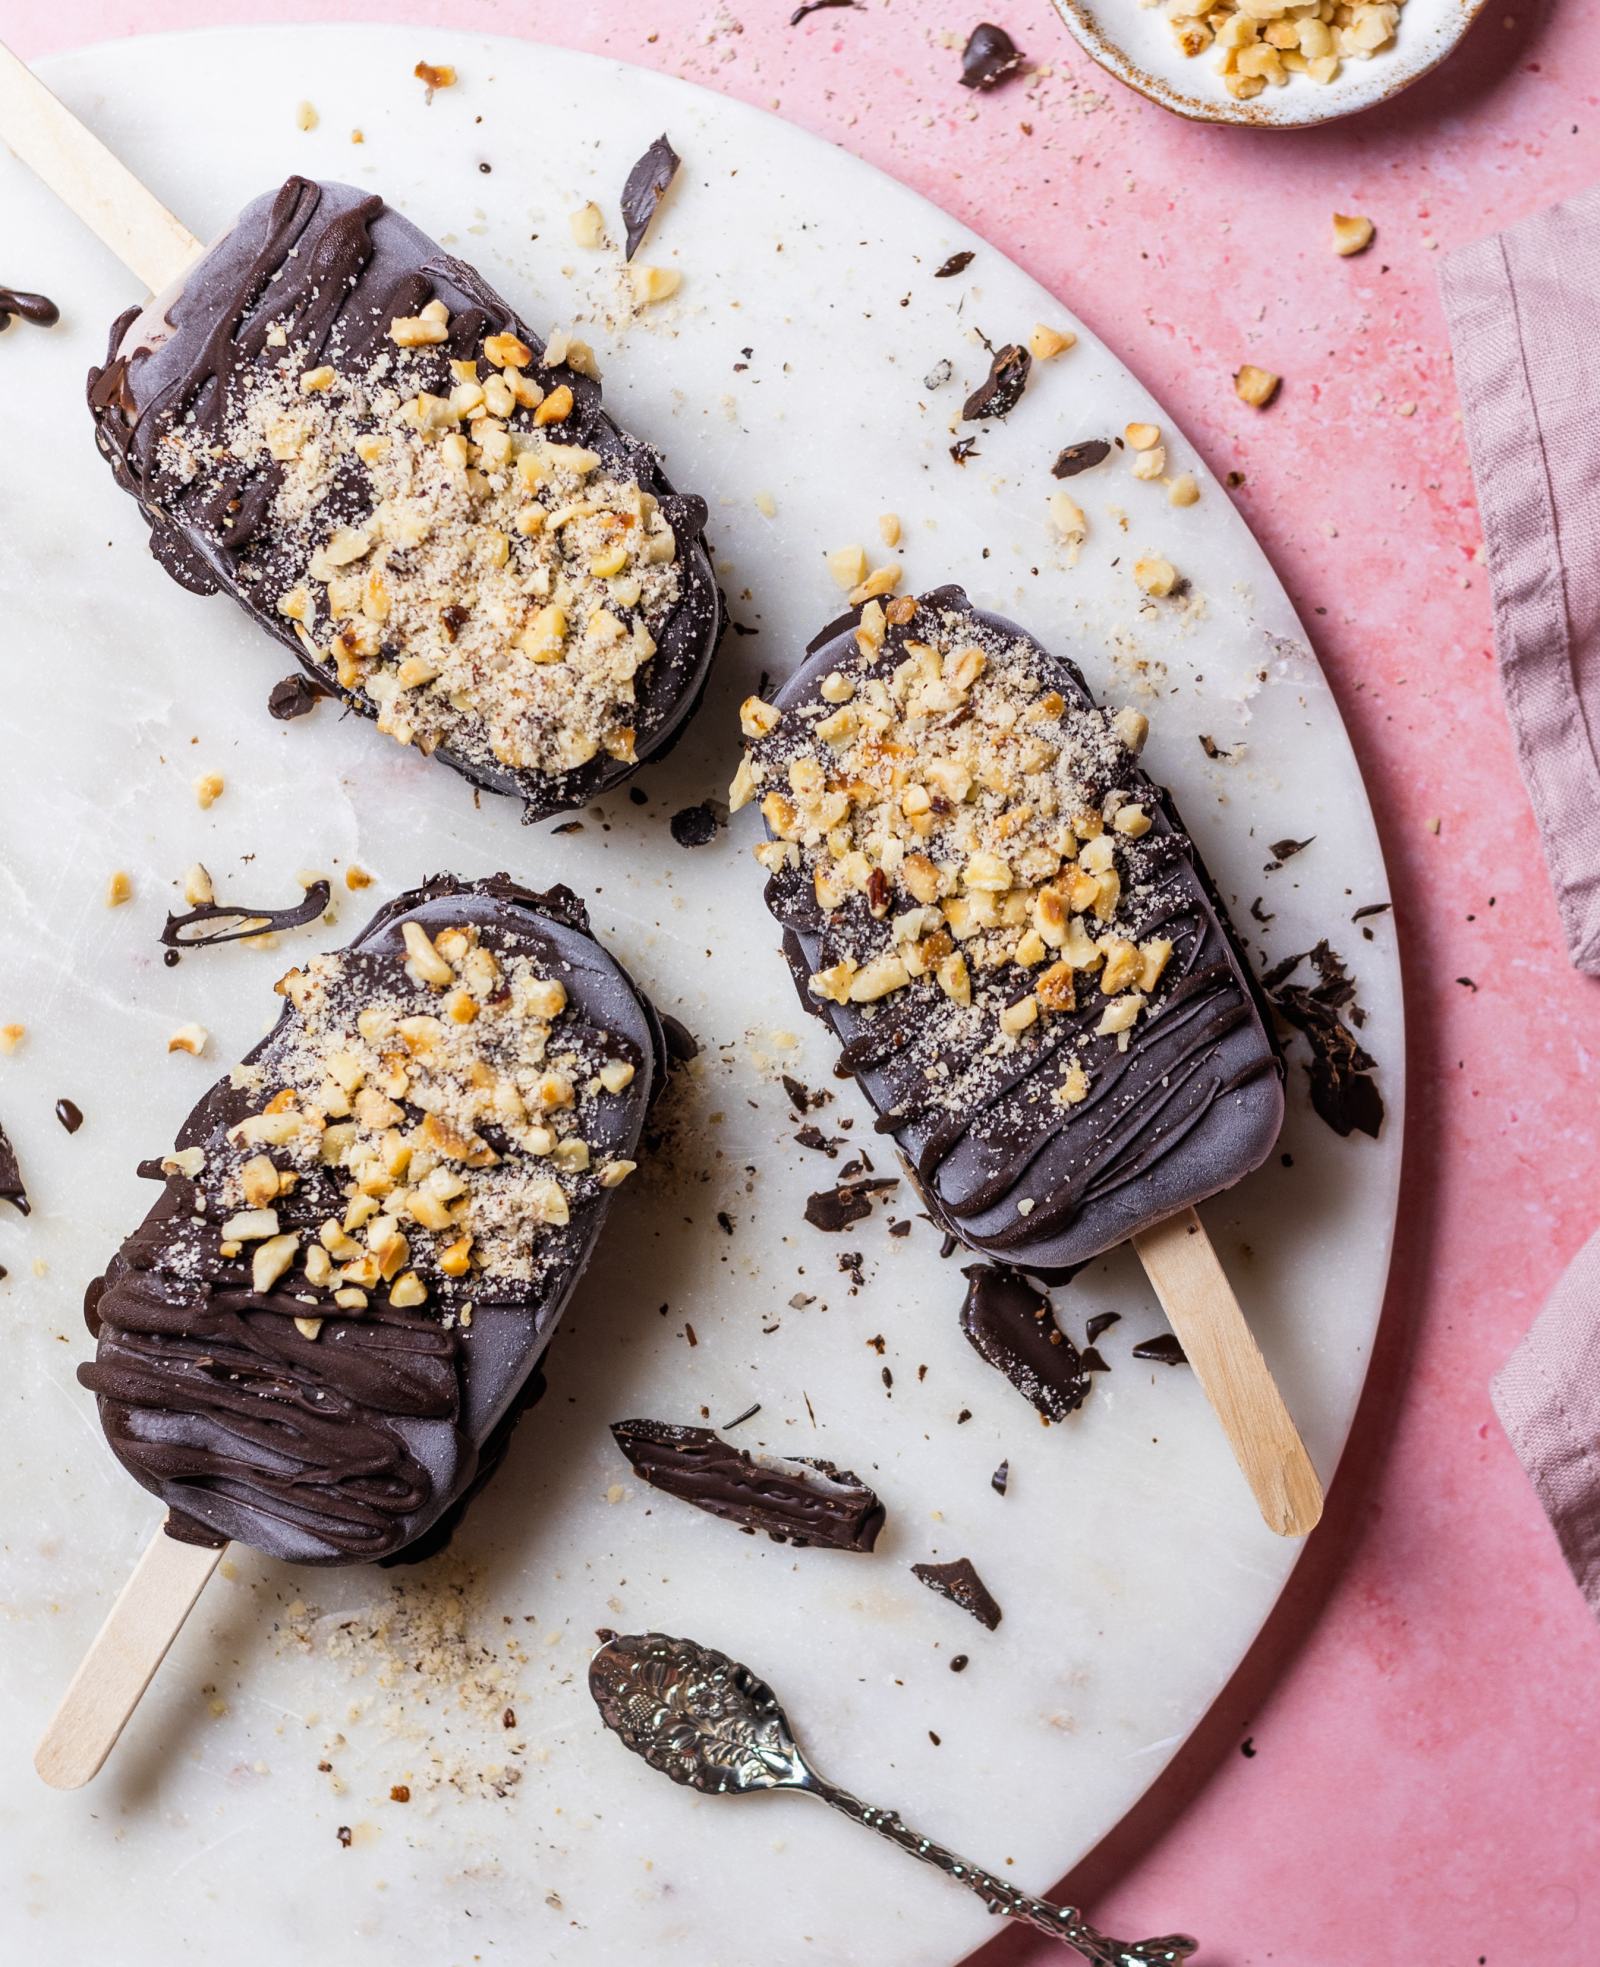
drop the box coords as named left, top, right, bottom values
left=588, top=1633, right=1197, bottom=1967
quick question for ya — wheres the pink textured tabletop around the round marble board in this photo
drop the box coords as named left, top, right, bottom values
left=12, top=0, right=1600, bottom=1967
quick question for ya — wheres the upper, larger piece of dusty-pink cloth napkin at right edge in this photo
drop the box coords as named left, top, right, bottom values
left=1441, top=189, right=1600, bottom=976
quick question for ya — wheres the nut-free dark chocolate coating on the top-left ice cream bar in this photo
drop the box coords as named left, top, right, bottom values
left=89, top=177, right=724, bottom=818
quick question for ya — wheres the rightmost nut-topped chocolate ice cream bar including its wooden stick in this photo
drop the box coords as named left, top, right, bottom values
left=730, top=586, right=1323, bottom=1536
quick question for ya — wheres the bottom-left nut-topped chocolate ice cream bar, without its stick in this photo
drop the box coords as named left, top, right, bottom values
left=79, top=875, right=661, bottom=1564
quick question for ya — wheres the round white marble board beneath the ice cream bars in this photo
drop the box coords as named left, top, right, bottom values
left=0, top=30, right=1401, bottom=1967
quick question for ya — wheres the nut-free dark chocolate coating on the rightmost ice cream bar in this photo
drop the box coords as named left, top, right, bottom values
left=766, top=586, right=1283, bottom=1271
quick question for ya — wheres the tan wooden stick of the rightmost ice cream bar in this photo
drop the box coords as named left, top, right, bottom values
left=1134, top=1210, right=1323, bottom=1536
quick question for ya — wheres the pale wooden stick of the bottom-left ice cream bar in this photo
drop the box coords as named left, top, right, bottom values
left=33, top=1530, right=228, bottom=1790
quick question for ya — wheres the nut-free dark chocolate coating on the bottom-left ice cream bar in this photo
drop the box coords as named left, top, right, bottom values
left=79, top=875, right=663, bottom=1564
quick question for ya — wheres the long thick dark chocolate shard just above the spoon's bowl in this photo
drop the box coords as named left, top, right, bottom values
left=612, top=1414, right=886, bottom=1550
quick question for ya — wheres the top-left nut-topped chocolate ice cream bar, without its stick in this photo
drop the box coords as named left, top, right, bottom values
left=89, top=177, right=722, bottom=818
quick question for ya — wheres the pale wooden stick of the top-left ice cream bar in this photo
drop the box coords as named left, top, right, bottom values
left=0, top=41, right=201, bottom=293
